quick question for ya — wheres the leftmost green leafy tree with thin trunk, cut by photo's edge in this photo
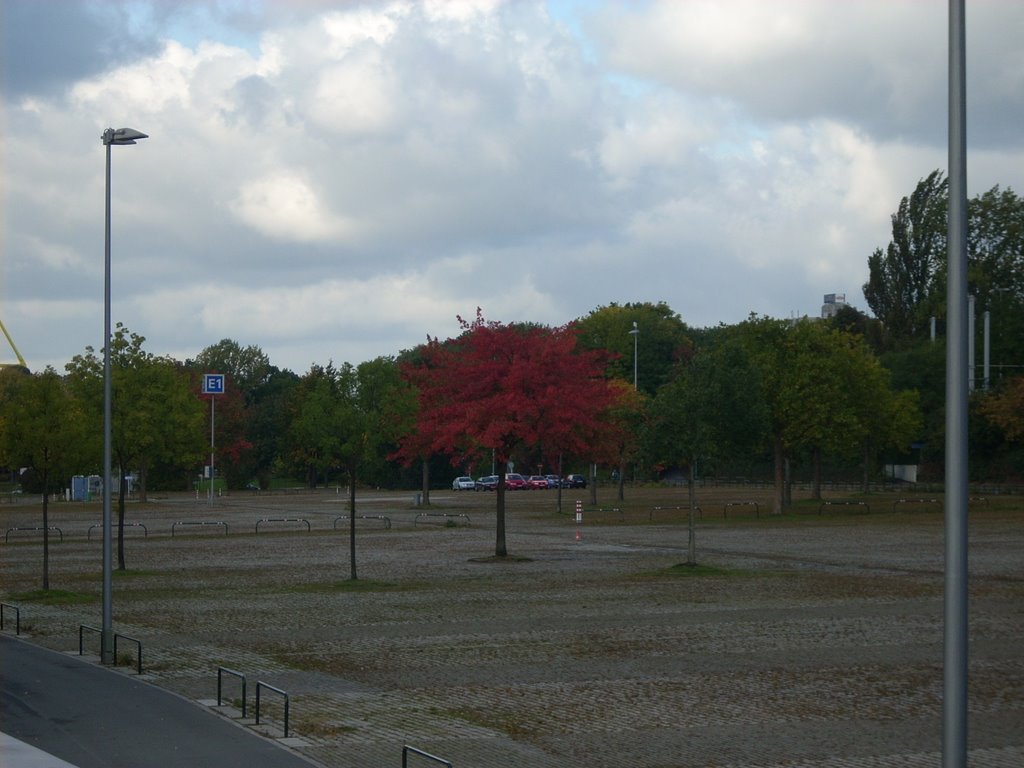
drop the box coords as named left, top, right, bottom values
left=0, top=368, right=85, bottom=590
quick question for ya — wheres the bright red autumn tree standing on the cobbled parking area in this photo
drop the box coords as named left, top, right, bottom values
left=398, top=309, right=615, bottom=557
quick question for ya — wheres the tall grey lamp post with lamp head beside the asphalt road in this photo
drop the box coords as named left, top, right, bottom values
left=99, top=128, right=148, bottom=664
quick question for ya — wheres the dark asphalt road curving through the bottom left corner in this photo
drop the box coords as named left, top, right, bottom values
left=0, top=636, right=313, bottom=768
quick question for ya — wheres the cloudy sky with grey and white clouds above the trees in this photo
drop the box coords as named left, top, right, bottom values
left=0, top=0, right=1024, bottom=373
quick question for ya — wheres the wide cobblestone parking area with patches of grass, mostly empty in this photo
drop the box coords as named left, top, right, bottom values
left=0, top=492, right=1024, bottom=768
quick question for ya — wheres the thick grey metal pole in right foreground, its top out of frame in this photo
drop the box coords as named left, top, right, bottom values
left=942, top=0, right=968, bottom=768
